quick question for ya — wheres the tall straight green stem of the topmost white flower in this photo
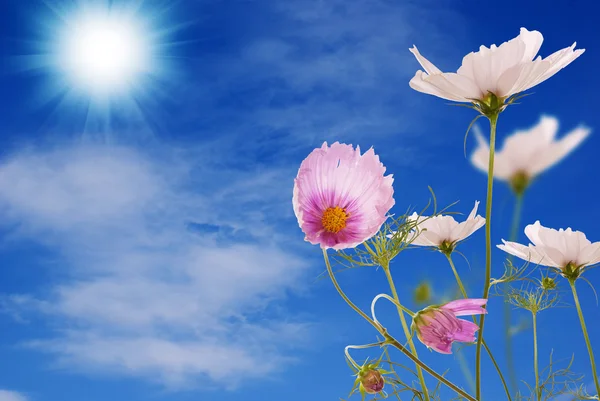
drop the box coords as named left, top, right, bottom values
left=475, top=114, right=498, bottom=400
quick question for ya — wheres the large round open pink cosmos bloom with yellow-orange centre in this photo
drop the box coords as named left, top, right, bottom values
left=292, top=142, right=394, bottom=249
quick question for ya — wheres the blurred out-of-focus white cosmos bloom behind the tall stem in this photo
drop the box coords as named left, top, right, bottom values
left=471, top=116, right=591, bottom=189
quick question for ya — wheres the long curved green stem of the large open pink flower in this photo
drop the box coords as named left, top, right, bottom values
left=323, top=249, right=477, bottom=401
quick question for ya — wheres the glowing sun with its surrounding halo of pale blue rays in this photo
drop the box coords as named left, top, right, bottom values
left=12, top=0, right=180, bottom=133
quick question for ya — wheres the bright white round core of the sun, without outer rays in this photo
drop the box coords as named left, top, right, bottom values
left=61, top=13, right=149, bottom=93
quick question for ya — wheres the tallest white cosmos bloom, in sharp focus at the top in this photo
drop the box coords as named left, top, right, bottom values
left=410, top=28, right=585, bottom=103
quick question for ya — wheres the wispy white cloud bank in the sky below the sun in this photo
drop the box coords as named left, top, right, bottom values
left=0, top=146, right=309, bottom=388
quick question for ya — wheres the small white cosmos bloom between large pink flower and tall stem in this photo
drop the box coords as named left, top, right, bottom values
left=388, top=201, right=485, bottom=251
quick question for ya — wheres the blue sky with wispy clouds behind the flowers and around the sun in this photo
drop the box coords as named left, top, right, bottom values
left=0, top=0, right=600, bottom=401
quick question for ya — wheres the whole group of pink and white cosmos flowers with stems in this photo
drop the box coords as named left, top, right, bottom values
left=293, top=28, right=600, bottom=400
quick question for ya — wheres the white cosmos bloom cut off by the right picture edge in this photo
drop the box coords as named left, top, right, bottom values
left=498, top=221, right=600, bottom=272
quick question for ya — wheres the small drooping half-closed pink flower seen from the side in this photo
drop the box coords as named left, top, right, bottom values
left=412, top=299, right=487, bottom=354
